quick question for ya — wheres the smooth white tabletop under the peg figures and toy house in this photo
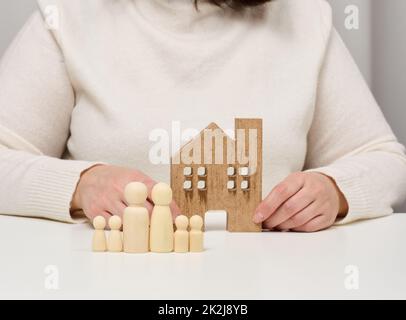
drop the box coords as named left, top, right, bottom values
left=0, top=214, right=406, bottom=299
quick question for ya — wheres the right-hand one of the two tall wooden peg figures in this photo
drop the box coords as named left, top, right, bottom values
left=150, top=183, right=174, bottom=252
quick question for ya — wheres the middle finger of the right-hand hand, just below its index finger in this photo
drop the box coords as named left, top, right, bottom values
left=264, top=188, right=315, bottom=229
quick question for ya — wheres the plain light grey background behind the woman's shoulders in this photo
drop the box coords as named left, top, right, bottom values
left=0, top=0, right=406, bottom=212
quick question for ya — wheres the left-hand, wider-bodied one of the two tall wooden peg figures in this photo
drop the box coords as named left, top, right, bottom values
left=123, top=182, right=149, bottom=253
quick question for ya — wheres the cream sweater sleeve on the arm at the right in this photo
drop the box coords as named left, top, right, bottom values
left=305, top=28, right=406, bottom=224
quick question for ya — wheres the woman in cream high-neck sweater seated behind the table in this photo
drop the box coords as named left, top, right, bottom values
left=0, top=0, right=406, bottom=231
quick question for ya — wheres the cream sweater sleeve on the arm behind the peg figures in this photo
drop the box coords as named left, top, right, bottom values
left=0, top=12, right=100, bottom=222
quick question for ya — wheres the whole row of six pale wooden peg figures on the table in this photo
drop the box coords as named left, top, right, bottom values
left=93, top=182, right=203, bottom=253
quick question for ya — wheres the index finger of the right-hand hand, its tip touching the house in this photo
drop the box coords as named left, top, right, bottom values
left=253, top=174, right=304, bottom=223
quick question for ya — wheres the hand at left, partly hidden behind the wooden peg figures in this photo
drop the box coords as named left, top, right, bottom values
left=71, top=165, right=180, bottom=220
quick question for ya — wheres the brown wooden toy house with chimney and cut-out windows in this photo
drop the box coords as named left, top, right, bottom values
left=171, top=119, right=262, bottom=232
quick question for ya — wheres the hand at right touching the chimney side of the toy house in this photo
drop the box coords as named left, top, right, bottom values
left=254, top=172, right=348, bottom=232
